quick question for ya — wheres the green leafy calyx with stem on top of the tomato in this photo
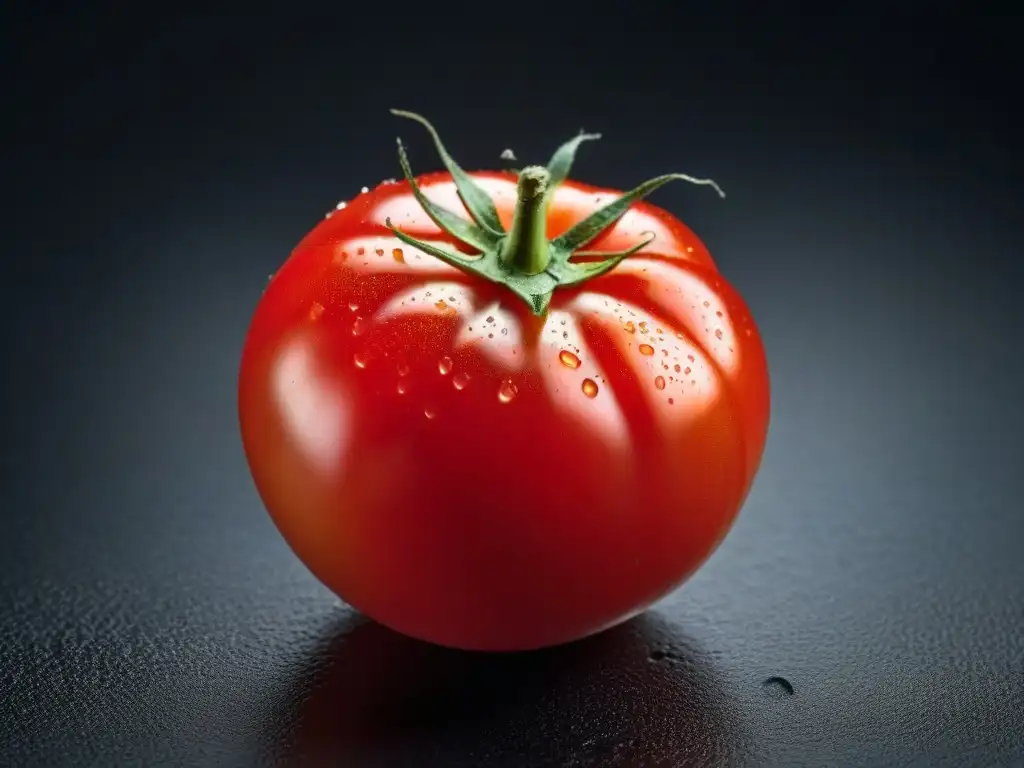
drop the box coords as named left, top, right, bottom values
left=385, top=110, right=725, bottom=316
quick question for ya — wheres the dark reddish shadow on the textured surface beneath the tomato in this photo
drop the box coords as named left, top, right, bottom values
left=268, top=613, right=740, bottom=768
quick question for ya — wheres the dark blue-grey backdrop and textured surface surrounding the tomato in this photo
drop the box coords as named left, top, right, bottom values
left=0, top=0, right=1024, bottom=768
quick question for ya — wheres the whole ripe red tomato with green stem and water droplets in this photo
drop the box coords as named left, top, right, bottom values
left=239, top=109, right=769, bottom=649
